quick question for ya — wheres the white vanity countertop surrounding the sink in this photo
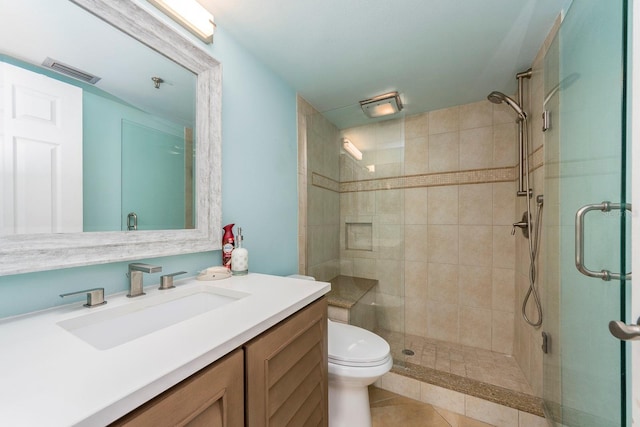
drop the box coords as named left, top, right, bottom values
left=0, top=273, right=331, bottom=426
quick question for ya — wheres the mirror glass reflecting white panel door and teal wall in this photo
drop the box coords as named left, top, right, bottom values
left=0, top=0, right=197, bottom=235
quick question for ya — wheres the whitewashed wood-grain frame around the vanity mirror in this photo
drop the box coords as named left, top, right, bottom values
left=0, top=0, right=221, bottom=275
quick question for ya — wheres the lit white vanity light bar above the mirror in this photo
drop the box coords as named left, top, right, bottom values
left=148, top=0, right=216, bottom=44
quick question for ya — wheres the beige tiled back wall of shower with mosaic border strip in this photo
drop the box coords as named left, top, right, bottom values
left=340, top=101, right=517, bottom=354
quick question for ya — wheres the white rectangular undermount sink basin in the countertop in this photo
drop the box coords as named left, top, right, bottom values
left=58, top=286, right=249, bottom=350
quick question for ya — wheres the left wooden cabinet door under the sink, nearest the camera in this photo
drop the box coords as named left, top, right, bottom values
left=112, top=349, right=244, bottom=427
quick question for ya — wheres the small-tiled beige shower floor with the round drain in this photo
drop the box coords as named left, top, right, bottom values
left=377, top=330, right=533, bottom=394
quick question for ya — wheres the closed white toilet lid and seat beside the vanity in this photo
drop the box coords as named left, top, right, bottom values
left=327, top=321, right=390, bottom=366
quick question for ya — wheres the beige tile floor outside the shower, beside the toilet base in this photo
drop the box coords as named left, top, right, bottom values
left=369, top=386, right=491, bottom=427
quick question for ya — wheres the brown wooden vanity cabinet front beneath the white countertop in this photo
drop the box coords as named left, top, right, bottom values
left=112, top=297, right=328, bottom=427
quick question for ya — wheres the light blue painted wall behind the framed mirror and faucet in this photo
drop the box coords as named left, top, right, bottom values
left=0, top=4, right=298, bottom=318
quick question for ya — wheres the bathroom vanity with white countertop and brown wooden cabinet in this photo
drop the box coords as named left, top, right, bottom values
left=0, top=274, right=330, bottom=426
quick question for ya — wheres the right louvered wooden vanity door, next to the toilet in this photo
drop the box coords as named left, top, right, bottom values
left=245, top=298, right=328, bottom=427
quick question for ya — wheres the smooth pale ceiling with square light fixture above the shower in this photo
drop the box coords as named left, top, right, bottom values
left=198, top=0, right=571, bottom=129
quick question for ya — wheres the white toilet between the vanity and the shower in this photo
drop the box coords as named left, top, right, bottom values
left=289, top=274, right=393, bottom=427
